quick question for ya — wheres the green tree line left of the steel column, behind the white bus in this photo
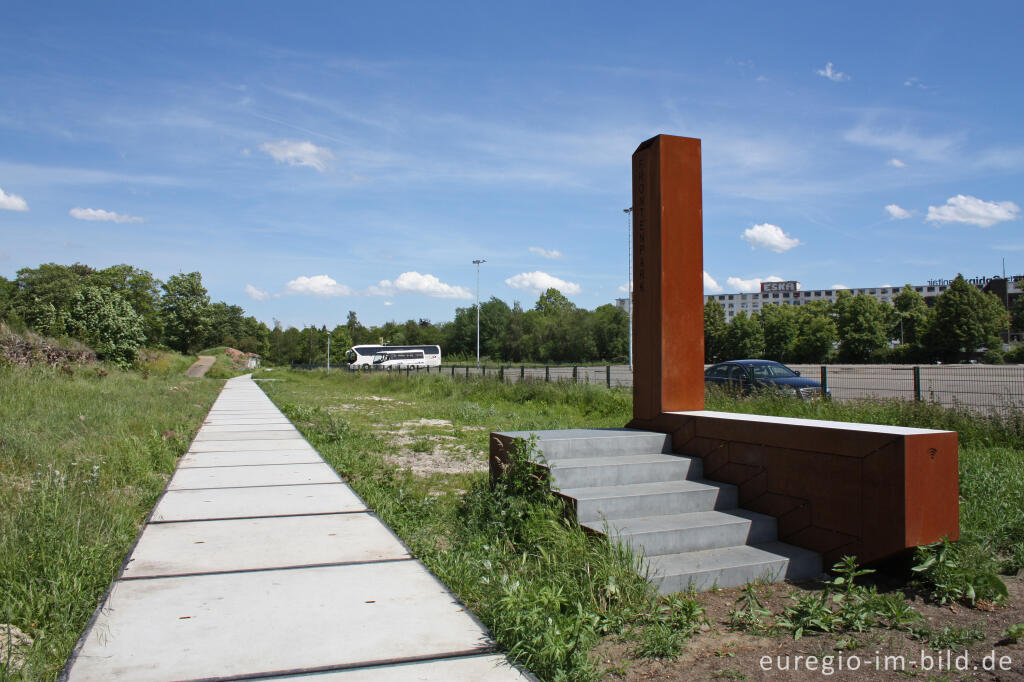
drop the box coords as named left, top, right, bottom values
left=0, top=263, right=629, bottom=365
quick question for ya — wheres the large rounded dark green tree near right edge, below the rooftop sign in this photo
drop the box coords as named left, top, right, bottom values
left=926, top=274, right=1010, bottom=360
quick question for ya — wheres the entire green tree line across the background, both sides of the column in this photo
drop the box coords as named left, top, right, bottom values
left=0, top=263, right=1024, bottom=365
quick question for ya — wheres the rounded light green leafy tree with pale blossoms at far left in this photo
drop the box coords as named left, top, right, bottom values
left=65, top=287, right=145, bottom=366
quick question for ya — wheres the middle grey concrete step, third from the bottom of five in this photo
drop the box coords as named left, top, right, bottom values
left=559, top=479, right=736, bottom=523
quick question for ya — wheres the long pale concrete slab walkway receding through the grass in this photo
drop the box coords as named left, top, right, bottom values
left=61, top=376, right=531, bottom=682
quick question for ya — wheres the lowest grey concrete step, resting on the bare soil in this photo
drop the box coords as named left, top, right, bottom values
left=645, top=541, right=821, bottom=594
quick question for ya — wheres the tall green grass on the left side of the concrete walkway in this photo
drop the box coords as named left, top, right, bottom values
left=0, top=352, right=220, bottom=680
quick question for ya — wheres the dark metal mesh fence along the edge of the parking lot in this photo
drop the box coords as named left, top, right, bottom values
left=337, top=365, right=1024, bottom=413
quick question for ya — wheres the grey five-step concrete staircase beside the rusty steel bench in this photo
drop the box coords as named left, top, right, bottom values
left=502, top=429, right=821, bottom=594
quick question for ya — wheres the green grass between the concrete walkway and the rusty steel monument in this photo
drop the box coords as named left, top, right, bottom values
left=260, top=370, right=702, bottom=680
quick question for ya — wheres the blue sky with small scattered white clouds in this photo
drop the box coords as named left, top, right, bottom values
left=0, top=2, right=1024, bottom=327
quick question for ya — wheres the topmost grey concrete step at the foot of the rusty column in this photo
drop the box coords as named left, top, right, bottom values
left=501, top=429, right=672, bottom=460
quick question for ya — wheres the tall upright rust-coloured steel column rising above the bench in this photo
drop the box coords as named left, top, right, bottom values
left=633, top=135, right=705, bottom=420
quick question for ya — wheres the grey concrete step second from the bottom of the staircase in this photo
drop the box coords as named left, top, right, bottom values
left=584, top=509, right=777, bottom=556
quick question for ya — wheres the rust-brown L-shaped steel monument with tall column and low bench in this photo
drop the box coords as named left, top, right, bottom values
left=629, top=135, right=959, bottom=562
